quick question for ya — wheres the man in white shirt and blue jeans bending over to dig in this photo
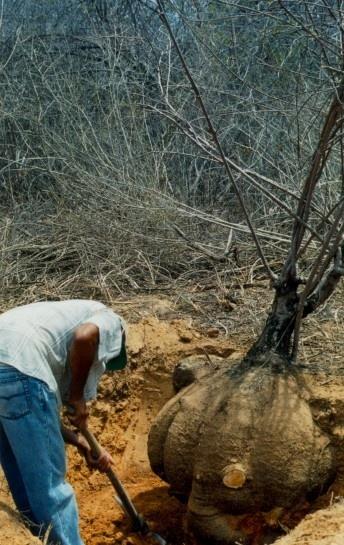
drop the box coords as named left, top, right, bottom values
left=0, top=300, right=126, bottom=545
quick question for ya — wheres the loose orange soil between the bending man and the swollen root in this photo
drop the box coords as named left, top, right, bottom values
left=70, top=317, right=239, bottom=545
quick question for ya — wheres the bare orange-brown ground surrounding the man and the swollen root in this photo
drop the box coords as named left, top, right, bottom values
left=0, top=281, right=344, bottom=545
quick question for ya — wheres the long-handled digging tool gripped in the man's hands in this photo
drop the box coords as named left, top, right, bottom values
left=80, top=428, right=167, bottom=545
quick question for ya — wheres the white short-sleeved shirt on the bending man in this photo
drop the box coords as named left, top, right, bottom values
left=0, top=299, right=122, bottom=403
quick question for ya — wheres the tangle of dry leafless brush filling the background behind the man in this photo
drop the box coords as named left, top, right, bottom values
left=0, top=2, right=341, bottom=306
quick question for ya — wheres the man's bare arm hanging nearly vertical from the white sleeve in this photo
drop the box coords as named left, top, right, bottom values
left=67, top=323, right=99, bottom=428
